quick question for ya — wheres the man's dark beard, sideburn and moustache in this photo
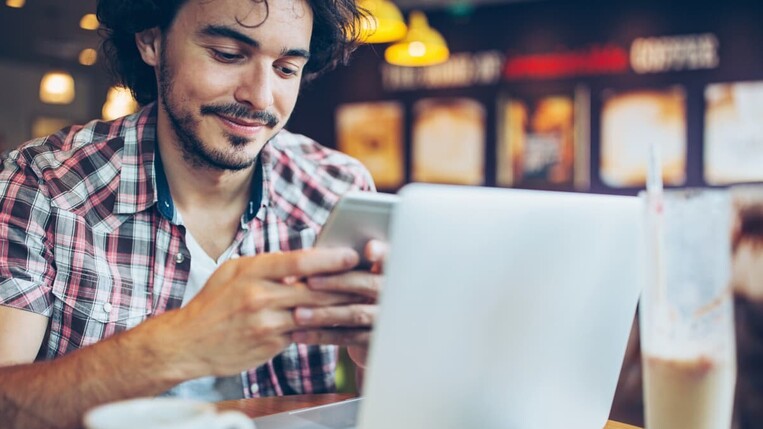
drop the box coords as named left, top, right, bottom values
left=159, top=50, right=279, bottom=171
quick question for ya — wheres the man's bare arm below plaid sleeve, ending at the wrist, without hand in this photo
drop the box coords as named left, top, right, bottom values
left=0, top=308, right=192, bottom=429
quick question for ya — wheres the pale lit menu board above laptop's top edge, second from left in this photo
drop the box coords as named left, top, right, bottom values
left=412, top=98, right=485, bottom=185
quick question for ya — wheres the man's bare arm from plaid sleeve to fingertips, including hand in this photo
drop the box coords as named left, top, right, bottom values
left=0, top=249, right=358, bottom=429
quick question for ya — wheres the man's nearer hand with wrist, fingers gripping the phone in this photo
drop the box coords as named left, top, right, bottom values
left=145, top=249, right=370, bottom=378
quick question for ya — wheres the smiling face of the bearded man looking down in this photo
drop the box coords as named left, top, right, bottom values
left=153, top=0, right=313, bottom=170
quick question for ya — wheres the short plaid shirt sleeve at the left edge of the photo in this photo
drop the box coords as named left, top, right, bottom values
left=0, top=151, right=55, bottom=316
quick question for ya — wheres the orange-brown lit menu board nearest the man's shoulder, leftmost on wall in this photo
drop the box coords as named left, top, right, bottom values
left=336, top=102, right=405, bottom=189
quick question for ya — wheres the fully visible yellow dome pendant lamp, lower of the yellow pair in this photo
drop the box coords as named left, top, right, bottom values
left=384, top=11, right=450, bottom=67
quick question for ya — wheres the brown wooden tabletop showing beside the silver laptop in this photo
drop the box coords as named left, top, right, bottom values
left=217, top=393, right=638, bottom=429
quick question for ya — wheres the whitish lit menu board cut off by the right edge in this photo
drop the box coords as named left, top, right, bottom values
left=704, top=82, right=763, bottom=185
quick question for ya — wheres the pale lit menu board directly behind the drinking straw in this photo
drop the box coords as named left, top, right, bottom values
left=599, top=86, right=687, bottom=188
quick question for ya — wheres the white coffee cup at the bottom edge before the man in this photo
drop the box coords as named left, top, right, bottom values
left=84, top=398, right=255, bottom=429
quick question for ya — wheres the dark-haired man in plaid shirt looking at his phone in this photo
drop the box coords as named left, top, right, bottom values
left=0, top=0, right=386, bottom=428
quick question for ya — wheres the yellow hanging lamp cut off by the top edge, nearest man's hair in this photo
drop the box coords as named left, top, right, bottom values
left=358, top=0, right=407, bottom=43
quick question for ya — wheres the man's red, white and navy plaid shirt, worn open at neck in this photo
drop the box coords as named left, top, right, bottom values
left=0, top=105, right=373, bottom=398
